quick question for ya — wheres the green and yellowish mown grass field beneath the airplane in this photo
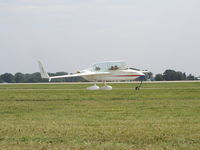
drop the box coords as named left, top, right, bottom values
left=0, top=82, right=200, bottom=150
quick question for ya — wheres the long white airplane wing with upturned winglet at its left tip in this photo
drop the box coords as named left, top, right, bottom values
left=38, top=61, right=110, bottom=81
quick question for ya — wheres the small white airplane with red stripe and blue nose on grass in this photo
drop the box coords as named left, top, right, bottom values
left=38, top=61, right=148, bottom=90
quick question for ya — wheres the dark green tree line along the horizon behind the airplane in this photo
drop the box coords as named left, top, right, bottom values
left=0, top=69, right=197, bottom=83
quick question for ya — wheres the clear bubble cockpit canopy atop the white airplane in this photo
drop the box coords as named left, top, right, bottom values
left=92, top=61, right=126, bottom=71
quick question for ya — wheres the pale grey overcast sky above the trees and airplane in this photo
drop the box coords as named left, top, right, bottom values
left=0, top=0, right=200, bottom=76
